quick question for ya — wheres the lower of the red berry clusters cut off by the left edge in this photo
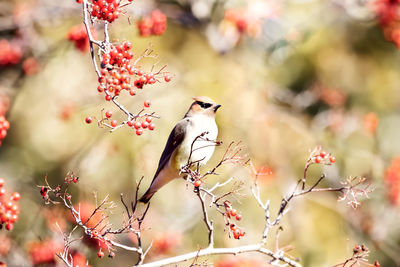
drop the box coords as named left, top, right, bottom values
left=0, top=178, right=21, bottom=230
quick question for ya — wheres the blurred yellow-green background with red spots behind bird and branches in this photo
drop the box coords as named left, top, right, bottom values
left=0, top=0, right=400, bottom=267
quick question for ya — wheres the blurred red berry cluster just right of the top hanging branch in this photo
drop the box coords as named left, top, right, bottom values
left=137, top=9, right=167, bottom=37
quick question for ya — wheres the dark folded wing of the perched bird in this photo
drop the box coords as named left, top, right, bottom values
left=152, top=118, right=190, bottom=183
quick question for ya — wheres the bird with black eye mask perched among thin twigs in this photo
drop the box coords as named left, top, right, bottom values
left=139, top=96, right=221, bottom=203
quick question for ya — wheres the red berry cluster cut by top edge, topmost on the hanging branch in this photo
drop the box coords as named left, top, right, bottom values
left=90, top=0, right=133, bottom=23
